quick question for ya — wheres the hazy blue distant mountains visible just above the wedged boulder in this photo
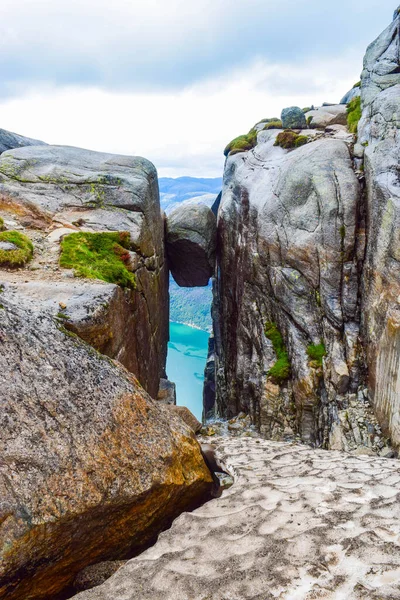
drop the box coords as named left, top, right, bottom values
left=158, top=177, right=222, bottom=213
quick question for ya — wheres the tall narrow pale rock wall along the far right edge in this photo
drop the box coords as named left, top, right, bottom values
left=358, top=7, right=400, bottom=447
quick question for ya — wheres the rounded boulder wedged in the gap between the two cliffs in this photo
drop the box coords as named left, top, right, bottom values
left=167, top=205, right=216, bottom=287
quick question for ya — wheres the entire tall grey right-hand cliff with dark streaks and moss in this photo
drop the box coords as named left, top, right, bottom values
left=209, top=11, right=400, bottom=451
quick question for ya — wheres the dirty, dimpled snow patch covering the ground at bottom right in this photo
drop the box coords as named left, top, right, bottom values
left=72, top=438, right=400, bottom=600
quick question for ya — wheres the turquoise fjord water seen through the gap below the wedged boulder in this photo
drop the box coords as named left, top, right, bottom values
left=167, top=322, right=210, bottom=421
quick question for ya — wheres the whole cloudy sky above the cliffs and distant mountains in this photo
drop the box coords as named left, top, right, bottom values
left=0, top=0, right=398, bottom=177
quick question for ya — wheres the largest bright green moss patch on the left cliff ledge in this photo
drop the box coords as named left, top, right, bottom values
left=60, top=231, right=136, bottom=289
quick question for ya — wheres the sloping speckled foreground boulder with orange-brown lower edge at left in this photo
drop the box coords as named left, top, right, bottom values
left=0, top=289, right=211, bottom=600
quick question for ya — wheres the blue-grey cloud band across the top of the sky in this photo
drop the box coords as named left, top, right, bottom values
left=0, top=0, right=393, bottom=97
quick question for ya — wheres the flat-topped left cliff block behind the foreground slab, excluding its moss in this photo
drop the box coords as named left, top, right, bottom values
left=0, top=146, right=168, bottom=397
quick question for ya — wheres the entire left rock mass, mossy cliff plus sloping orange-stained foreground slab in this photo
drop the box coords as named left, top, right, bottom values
left=0, top=142, right=215, bottom=600
